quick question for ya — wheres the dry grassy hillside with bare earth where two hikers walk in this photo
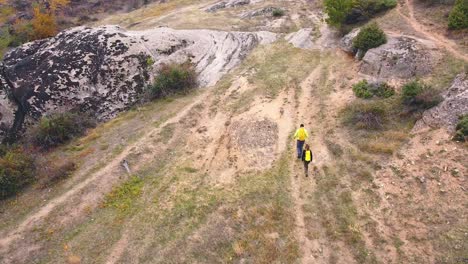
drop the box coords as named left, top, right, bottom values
left=0, top=0, right=468, bottom=264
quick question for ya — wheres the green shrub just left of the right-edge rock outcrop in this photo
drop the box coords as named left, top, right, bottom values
left=402, top=81, right=442, bottom=111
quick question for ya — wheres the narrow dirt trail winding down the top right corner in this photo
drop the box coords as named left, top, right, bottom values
left=397, top=0, right=468, bottom=61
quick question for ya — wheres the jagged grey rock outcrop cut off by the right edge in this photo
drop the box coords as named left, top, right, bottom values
left=414, top=73, right=468, bottom=131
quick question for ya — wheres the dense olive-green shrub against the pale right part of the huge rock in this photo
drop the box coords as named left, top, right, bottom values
left=148, top=62, right=197, bottom=100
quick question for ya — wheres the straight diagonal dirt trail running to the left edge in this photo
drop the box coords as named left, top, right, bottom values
left=0, top=91, right=208, bottom=253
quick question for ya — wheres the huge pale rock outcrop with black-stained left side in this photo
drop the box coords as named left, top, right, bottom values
left=0, top=26, right=276, bottom=142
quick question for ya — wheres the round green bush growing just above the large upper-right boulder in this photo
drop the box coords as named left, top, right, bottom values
left=353, top=23, right=387, bottom=58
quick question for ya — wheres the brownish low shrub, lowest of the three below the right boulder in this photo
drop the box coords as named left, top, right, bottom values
left=344, top=102, right=386, bottom=130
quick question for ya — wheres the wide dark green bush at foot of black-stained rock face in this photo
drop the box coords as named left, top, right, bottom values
left=28, top=112, right=96, bottom=149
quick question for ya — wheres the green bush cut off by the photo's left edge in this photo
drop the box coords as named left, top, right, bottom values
left=0, top=147, right=35, bottom=199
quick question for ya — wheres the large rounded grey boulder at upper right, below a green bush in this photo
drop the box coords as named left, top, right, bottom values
left=360, top=36, right=440, bottom=79
